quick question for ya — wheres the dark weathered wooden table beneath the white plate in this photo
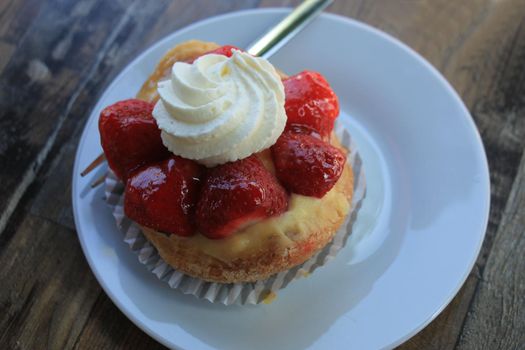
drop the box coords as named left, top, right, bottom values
left=0, top=0, right=525, bottom=349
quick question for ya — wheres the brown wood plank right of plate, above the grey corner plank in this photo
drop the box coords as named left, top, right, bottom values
left=445, top=1, right=525, bottom=262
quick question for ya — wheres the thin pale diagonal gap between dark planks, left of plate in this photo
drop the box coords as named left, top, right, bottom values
left=0, top=1, right=139, bottom=235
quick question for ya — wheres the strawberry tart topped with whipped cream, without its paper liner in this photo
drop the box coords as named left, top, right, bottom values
left=99, top=40, right=353, bottom=283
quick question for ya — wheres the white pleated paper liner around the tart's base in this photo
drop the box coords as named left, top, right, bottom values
left=105, top=124, right=366, bottom=305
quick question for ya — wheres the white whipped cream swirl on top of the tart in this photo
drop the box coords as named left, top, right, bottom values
left=153, top=50, right=286, bottom=167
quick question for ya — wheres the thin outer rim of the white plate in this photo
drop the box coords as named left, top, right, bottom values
left=71, top=7, right=491, bottom=349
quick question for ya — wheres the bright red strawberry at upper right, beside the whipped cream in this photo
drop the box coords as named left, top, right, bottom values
left=283, top=71, right=339, bottom=138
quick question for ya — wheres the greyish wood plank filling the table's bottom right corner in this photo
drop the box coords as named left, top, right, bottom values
left=458, top=146, right=525, bottom=350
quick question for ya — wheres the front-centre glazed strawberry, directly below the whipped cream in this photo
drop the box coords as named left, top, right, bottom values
left=196, top=156, right=288, bottom=238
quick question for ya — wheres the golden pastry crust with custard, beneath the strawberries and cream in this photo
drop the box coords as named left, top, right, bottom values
left=137, top=40, right=354, bottom=283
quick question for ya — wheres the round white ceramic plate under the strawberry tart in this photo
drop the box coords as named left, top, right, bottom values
left=73, top=9, right=490, bottom=349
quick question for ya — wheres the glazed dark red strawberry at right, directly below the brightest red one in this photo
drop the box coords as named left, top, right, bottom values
left=272, top=132, right=346, bottom=198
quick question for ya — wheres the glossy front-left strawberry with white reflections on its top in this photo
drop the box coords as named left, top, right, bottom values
left=124, top=156, right=203, bottom=236
